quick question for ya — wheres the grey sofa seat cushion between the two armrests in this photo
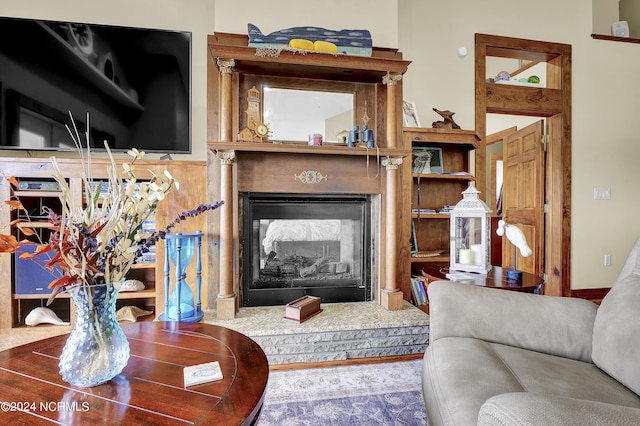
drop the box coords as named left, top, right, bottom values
left=422, top=338, right=640, bottom=425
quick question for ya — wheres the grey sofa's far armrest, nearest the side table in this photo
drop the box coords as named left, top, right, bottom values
left=428, top=281, right=597, bottom=362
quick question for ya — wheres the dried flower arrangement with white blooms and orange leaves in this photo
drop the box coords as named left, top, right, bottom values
left=0, top=115, right=223, bottom=303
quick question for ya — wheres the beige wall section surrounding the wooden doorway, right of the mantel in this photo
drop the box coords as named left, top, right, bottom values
left=398, top=0, right=640, bottom=289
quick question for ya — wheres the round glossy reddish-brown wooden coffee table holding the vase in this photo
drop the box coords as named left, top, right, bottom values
left=0, top=322, right=269, bottom=425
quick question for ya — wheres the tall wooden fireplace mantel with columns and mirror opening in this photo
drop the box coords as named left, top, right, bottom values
left=207, top=33, right=411, bottom=319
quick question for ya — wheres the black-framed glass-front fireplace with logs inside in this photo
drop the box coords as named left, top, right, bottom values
left=241, top=192, right=372, bottom=306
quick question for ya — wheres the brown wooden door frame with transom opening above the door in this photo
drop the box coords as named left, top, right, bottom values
left=475, top=34, right=571, bottom=296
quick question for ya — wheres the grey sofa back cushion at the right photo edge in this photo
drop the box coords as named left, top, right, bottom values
left=591, top=273, right=640, bottom=395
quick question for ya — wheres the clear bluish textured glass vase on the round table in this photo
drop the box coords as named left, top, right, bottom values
left=59, top=283, right=129, bottom=387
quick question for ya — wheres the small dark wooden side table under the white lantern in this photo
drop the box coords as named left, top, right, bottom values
left=422, top=265, right=544, bottom=294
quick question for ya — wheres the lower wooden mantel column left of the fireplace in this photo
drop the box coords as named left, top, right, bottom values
left=217, top=151, right=237, bottom=319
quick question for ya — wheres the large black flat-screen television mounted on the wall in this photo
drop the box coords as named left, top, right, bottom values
left=0, top=17, right=192, bottom=153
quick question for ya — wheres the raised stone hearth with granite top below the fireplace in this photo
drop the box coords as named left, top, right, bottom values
left=203, top=302, right=429, bottom=365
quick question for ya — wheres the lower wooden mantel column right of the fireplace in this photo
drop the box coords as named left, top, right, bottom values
left=380, top=157, right=402, bottom=311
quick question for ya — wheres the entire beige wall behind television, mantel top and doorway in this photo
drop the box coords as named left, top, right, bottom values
left=0, top=0, right=640, bottom=289
